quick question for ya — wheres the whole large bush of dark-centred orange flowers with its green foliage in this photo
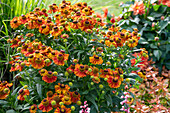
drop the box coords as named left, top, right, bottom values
left=0, top=0, right=148, bottom=113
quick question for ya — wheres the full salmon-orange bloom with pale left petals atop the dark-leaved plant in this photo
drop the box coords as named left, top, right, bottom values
left=129, top=1, right=145, bottom=15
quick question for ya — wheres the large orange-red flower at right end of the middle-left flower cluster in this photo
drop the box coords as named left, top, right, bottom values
left=53, top=51, right=69, bottom=66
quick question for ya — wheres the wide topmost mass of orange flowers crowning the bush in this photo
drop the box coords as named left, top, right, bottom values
left=10, top=0, right=104, bottom=35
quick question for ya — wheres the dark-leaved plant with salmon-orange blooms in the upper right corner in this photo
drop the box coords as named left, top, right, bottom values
left=108, top=0, right=170, bottom=71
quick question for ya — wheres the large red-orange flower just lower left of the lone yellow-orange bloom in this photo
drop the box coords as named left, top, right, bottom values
left=74, top=64, right=87, bottom=77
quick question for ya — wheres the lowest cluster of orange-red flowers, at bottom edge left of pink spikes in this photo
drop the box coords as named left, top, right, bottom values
left=38, top=83, right=81, bottom=113
